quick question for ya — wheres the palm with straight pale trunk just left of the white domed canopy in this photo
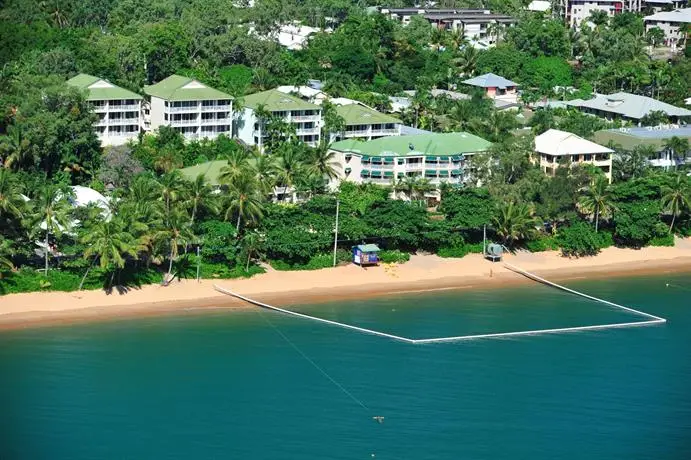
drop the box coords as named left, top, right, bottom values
left=31, top=184, right=70, bottom=276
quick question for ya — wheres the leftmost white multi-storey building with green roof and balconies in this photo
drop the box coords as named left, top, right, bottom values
left=67, top=73, right=144, bottom=146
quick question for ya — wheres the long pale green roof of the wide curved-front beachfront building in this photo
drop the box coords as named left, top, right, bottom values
left=331, top=132, right=492, bottom=157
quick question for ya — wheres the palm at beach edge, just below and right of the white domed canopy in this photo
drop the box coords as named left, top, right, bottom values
left=79, top=218, right=137, bottom=291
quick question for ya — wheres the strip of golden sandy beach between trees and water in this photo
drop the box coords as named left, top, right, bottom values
left=0, top=238, right=691, bottom=329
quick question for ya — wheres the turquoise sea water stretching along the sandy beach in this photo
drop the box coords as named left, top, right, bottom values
left=0, top=275, right=691, bottom=460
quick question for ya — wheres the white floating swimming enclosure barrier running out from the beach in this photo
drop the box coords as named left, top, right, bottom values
left=214, top=263, right=667, bottom=344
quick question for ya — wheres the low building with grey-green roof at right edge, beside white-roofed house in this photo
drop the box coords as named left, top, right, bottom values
left=593, top=125, right=691, bottom=168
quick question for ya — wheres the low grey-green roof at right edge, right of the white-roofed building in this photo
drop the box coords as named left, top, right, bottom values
left=593, top=125, right=691, bottom=150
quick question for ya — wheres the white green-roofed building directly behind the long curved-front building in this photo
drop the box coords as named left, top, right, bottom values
left=332, top=99, right=401, bottom=141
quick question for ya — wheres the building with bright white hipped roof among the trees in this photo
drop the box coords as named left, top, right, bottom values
left=535, top=129, right=614, bottom=183
